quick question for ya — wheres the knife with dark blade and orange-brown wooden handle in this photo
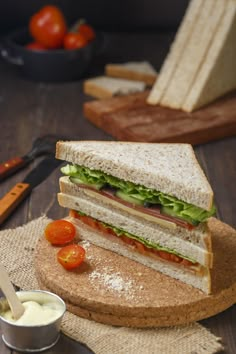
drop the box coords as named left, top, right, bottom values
left=0, top=155, right=62, bottom=225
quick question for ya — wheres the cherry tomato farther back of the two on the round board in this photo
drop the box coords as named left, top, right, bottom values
left=45, top=220, right=76, bottom=245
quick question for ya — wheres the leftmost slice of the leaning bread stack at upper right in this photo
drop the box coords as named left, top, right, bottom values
left=147, top=0, right=205, bottom=105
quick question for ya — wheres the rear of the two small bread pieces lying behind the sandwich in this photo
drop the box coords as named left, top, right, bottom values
left=105, top=61, right=157, bottom=85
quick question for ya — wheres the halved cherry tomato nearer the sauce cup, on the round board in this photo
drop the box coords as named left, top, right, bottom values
left=57, top=244, right=85, bottom=270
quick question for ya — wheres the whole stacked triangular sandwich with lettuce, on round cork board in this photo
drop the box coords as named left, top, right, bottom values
left=56, top=141, right=215, bottom=293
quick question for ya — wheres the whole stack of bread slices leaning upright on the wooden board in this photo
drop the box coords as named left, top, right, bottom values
left=147, top=0, right=236, bottom=112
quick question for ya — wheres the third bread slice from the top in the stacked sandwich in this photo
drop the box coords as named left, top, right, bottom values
left=58, top=190, right=213, bottom=267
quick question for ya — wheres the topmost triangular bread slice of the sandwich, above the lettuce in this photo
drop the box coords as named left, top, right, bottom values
left=56, top=141, right=213, bottom=210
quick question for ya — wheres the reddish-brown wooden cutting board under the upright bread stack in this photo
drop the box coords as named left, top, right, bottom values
left=84, top=91, right=236, bottom=145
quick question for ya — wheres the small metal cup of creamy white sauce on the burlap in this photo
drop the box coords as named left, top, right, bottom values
left=0, top=290, right=66, bottom=353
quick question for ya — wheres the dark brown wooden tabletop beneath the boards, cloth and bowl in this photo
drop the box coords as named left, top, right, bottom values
left=0, top=33, right=236, bottom=354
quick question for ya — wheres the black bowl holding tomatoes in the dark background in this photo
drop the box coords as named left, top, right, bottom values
left=0, top=29, right=103, bottom=82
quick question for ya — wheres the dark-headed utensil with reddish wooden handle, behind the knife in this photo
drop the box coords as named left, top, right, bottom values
left=0, top=135, right=69, bottom=181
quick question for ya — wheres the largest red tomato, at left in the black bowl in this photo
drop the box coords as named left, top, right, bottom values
left=29, top=5, right=67, bottom=49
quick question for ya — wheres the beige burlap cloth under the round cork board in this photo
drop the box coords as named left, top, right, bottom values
left=0, top=216, right=223, bottom=354
